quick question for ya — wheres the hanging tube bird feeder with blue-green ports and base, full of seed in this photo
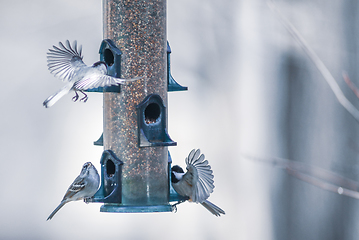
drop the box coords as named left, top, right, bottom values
left=91, top=0, right=187, bottom=212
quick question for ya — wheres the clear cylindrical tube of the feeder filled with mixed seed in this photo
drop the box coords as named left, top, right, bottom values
left=103, top=0, right=169, bottom=206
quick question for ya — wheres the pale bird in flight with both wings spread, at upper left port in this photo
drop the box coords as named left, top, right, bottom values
left=43, top=40, right=141, bottom=108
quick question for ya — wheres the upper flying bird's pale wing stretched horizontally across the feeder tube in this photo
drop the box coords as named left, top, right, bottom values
left=74, top=73, right=142, bottom=90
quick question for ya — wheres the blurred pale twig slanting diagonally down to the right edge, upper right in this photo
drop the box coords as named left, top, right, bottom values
left=267, top=0, right=359, bottom=122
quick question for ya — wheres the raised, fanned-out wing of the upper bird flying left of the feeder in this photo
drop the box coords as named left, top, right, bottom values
left=47, top=40, right=86, bottom=81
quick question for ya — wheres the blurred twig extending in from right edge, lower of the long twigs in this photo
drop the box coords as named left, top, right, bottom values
left=242, top=155, right=359, bottom=199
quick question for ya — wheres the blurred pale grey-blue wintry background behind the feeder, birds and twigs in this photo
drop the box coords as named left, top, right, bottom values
left=0, top=0, right=359, bottom=240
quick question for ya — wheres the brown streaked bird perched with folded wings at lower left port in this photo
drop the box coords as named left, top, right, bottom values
left=46, top=162, right=100, bottom=221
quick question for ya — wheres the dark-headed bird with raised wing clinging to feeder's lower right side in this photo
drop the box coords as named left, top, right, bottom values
left=171, top=149, right=225, bottom=217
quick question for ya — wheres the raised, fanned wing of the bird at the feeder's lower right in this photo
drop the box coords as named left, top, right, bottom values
left=184, top=149, right=214, bottom=203
